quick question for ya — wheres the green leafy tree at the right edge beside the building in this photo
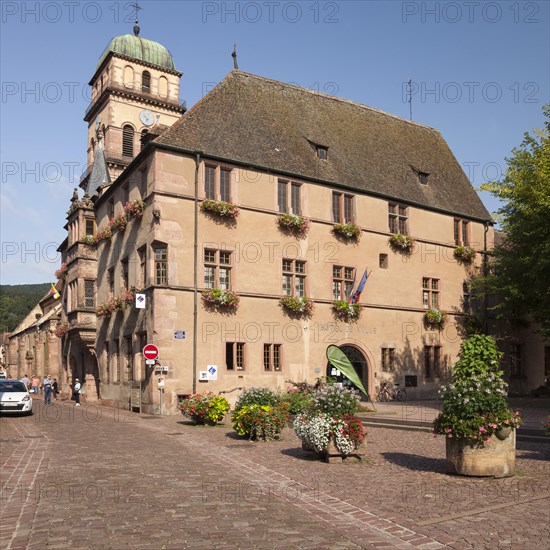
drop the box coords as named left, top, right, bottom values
left=482, top=105, right=550, bottom=336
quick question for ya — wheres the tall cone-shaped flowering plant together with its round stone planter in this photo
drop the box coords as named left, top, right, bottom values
left=433, top=334, right=522, bottom=477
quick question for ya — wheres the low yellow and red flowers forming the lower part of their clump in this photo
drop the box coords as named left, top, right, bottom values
left=231, top=403, right=288, bottom=441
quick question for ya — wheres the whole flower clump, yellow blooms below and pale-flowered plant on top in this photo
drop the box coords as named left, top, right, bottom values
left=231, top=387, right=288, bottom=441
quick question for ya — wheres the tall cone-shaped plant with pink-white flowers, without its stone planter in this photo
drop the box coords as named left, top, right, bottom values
left=433, top=334, right=522, bottom=446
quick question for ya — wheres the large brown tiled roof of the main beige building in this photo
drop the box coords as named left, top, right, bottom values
left=155, top=70, right=490, bottom=219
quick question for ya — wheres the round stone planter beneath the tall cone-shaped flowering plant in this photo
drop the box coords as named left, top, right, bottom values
left=445, top=429, right=516, bottom=477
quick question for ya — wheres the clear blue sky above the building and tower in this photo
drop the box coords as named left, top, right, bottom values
left=0, top=0, right=550, bottom=284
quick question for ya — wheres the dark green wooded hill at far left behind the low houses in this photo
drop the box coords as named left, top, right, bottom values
left=0, top=283, right=50, bottom=332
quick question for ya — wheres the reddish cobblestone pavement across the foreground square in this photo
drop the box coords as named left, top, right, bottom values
left=0, top=401, right=550, bottom=550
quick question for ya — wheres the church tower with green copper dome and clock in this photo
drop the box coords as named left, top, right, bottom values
left=81, top=21, right=185, bottom=190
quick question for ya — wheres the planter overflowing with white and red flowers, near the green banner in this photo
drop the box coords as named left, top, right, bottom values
left=294, top=385, right=366, bottom=462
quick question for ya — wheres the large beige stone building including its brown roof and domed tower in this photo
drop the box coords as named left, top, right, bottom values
left=6, top=22, right=550, bottom=413
